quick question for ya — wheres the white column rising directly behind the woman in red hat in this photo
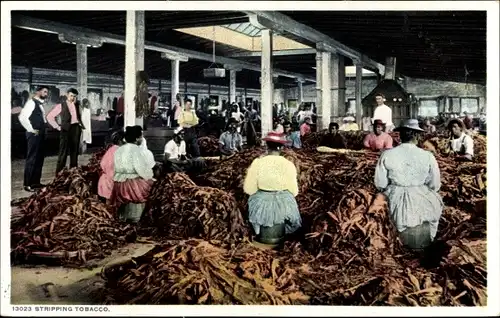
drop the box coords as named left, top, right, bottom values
left=260, top=29, right=274, bottom=136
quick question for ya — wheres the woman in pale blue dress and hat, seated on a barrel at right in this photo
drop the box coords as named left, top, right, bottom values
left=375, top=119, right=443, bottom=250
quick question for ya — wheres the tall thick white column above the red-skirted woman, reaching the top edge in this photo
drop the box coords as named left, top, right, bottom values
left=124, top=10, right=145, bottom=127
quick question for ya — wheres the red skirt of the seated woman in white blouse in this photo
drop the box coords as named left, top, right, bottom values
left=111, top=178, right=153, bottom=206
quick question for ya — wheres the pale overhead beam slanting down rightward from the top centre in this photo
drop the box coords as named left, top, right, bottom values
left=247, top=11, right=385, bottom=74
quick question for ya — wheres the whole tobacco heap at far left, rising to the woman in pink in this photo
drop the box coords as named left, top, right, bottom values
left=11, top=149, right=136, bottom=266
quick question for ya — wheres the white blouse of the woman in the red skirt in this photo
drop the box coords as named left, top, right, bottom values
left=113, top=143, right=156, bottom=182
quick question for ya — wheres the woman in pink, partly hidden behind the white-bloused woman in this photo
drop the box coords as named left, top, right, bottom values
left=97, top=130, right=124, bottom=200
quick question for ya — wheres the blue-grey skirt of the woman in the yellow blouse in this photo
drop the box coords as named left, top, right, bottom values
left=248, top=190, right=302, bottom=235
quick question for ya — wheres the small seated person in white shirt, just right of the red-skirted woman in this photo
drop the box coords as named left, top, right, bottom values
left=163, top=127, right=204, bottom=173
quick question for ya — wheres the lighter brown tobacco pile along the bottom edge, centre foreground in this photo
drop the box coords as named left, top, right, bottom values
left=104, top=240, right=308, bottom=305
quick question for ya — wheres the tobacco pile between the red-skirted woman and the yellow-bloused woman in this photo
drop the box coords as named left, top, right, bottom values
left=142, top=173, right=248, bottom=240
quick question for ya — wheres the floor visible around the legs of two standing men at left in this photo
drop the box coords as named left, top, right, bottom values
left=10, top=154, right=91, bottom=200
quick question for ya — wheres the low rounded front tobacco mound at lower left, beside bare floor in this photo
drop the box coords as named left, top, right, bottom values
left=11, top=195, right=135, bottom=265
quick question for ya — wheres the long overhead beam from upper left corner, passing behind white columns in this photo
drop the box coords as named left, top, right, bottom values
left=11, top=15, right=316, bottom=82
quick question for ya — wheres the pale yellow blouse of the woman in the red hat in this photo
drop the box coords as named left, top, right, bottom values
left=243, top=155, right=299, bottom=196
